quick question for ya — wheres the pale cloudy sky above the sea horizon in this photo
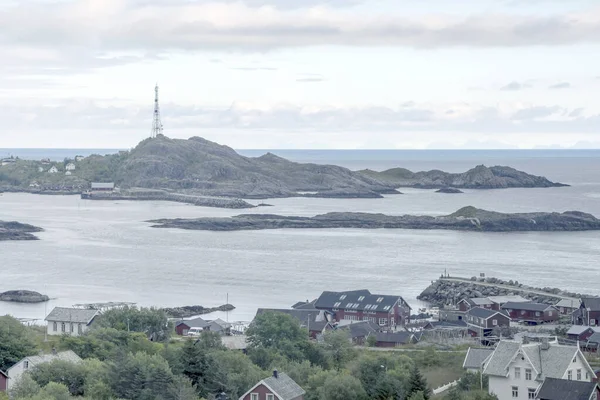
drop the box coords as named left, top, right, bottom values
left=0, top=0, right=600, bottom=149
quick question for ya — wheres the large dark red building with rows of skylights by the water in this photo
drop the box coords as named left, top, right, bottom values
left=315, top=289, right=411, bottom=327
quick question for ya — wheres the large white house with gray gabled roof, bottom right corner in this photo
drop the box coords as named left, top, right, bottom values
left=483, top=340, right=596, bottom=400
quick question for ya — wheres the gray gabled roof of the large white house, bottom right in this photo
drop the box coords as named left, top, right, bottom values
left=484, top=341, right=579, bottom=380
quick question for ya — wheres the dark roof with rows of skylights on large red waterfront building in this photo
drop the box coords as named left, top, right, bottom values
left=315, top=290, right=402, bottom=312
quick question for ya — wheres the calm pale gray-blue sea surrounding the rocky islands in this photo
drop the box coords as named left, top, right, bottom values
left=0, top=149, right=600, bottom=323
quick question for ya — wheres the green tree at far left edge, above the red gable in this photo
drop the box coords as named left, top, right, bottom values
left=0, top=315, right=36, bottom=371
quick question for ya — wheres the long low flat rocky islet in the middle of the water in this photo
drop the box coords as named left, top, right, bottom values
left=149, top=206, right=600, bottom=232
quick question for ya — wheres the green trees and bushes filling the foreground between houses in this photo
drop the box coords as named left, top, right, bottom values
left=0, top=308, right=490, bottom=400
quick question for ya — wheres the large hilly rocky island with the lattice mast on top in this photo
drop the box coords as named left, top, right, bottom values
left=0, top=135, right=564, bottom=203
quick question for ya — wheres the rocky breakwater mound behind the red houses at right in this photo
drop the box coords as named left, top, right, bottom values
left=417, top=277, right=591, bottom=307
